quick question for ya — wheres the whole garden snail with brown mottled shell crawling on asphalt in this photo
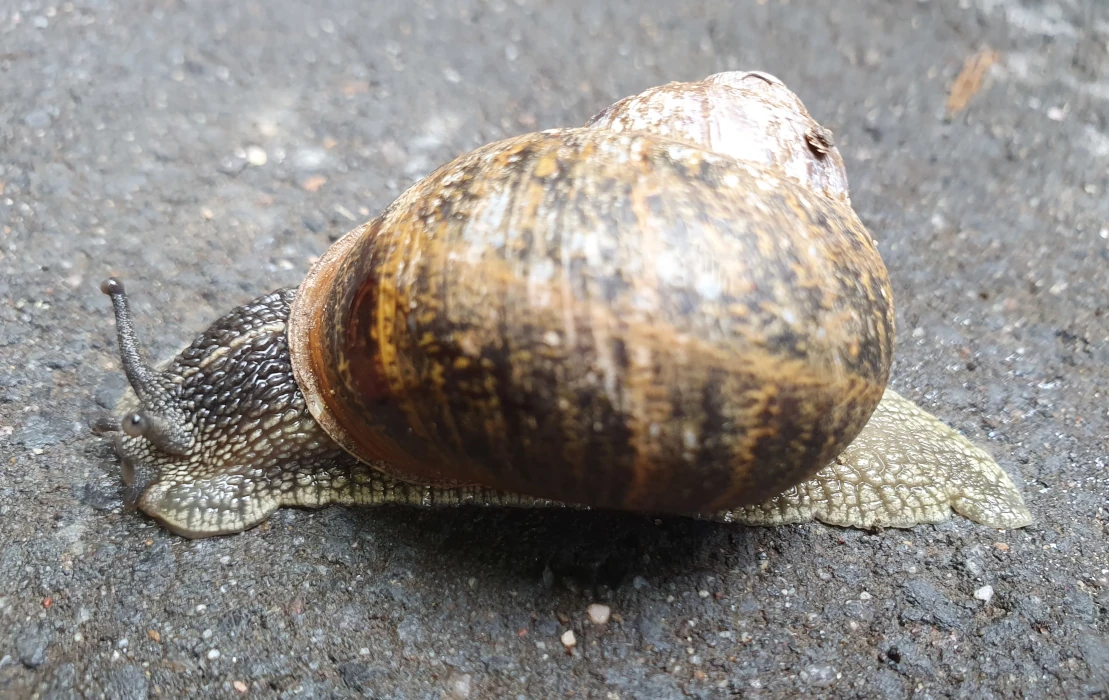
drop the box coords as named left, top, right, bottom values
left=100, top=72, right=1031, bottom=537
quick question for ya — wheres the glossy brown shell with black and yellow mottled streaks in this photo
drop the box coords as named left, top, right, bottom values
left=289, top=73, right=894, bottom=514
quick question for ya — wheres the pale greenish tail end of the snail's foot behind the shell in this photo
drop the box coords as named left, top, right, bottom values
left=712, top=389, right=1032, bottom=529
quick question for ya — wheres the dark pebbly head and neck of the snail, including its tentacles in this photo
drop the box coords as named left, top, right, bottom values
left=94, top=278, right=337, bottom=537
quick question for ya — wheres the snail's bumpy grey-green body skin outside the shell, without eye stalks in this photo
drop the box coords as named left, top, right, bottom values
left=108, top=290, right=1031, bottom=537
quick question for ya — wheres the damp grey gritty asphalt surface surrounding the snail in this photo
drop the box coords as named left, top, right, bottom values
left=0, top=0, right=1109, bottom=700
